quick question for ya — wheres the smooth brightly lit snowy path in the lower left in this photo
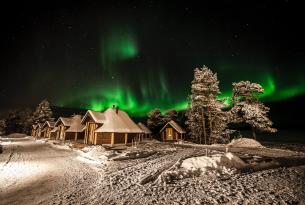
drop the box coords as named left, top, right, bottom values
left=0, top=138, right=99, bottom=204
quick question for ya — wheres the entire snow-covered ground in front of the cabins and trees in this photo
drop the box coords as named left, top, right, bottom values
left=0, top=137, right=305, bottom=204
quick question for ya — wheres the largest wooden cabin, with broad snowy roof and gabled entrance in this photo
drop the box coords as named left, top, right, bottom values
left=82, top=108, right=143, bottom=146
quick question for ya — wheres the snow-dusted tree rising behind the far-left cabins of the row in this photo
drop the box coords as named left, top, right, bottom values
left=33, top=100, right=53, bottom=124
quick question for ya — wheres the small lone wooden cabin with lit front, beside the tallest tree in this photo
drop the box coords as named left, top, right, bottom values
left=160, top=120, right=186, bottom=142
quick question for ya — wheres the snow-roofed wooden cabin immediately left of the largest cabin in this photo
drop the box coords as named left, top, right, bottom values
left=65, top=115, right=85, bottom=140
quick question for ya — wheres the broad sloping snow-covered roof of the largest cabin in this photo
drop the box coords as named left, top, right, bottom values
left=95, top=108, right=143, bottom=133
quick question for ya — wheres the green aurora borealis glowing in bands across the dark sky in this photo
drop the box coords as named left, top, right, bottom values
left=57, top=28, right=305, bottom=116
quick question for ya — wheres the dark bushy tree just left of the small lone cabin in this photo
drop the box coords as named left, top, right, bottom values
left=147, top=109, right=164, bottom=134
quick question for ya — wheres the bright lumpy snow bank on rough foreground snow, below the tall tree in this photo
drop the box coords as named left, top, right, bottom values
left=181, top=152, right=245, bottom=174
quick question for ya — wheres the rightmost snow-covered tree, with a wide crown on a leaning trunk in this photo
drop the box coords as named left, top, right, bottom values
left=231, top=81, right=277, bottom=139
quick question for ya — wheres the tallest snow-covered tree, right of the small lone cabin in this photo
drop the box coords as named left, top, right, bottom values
left=187, top=66, right=228, bottom=144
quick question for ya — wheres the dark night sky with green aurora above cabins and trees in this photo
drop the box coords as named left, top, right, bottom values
left=0, top=0, right=305, bottom=116
